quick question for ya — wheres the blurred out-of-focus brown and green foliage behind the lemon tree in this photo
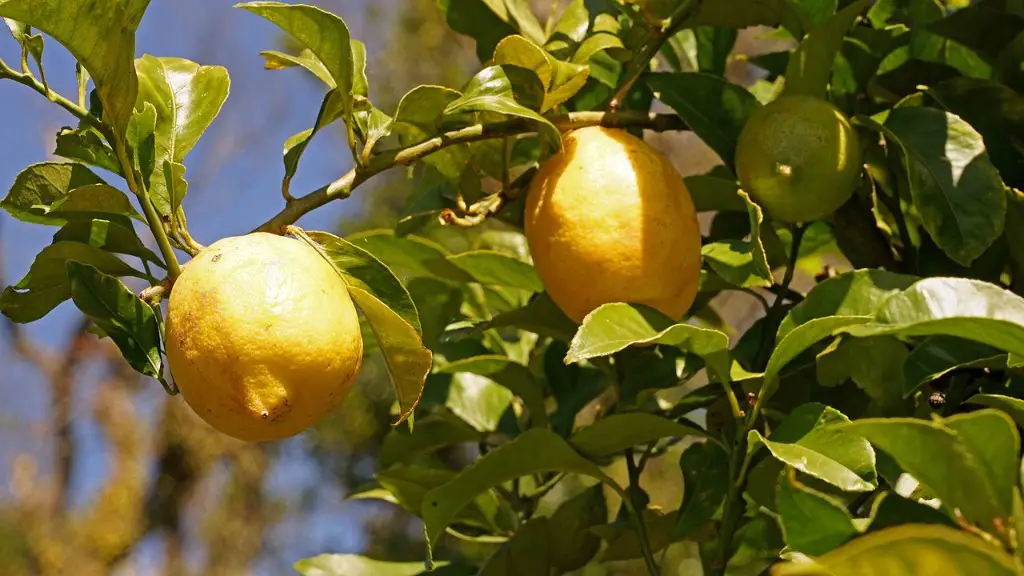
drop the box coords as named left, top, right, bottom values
left=0, top=0, right=790, bottom=576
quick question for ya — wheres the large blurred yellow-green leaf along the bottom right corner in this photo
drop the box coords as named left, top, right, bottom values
left=772, top=524, right=1017, bottom=576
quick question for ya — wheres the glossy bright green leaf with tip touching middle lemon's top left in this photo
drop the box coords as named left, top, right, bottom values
left=444, top=66, right=561, bottom=150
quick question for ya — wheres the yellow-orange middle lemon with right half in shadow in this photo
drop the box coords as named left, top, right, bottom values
left=525, top=126, right=700, bottom=322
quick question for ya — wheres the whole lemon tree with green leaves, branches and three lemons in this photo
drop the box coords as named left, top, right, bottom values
left=0, top=0, right=1024, bottom=576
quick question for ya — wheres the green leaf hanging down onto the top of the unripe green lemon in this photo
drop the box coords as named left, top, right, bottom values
left=782, top=0, right=871, bottom=98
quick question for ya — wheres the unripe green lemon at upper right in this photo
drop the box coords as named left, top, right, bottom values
left=736, top=95, right=861, bottom=222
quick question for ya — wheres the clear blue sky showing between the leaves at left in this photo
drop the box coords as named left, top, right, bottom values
left=0, top=0, right=387, bottom=572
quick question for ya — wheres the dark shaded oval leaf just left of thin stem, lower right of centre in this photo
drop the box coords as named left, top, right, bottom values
left=672, top=442, right=730, bottom=540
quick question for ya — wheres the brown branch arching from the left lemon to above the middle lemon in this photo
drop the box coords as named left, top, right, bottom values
left=254, top=112, right=687, bottom=234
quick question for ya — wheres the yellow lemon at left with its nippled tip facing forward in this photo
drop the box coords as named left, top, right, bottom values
left=166, top=233, right=362, bottom=442
